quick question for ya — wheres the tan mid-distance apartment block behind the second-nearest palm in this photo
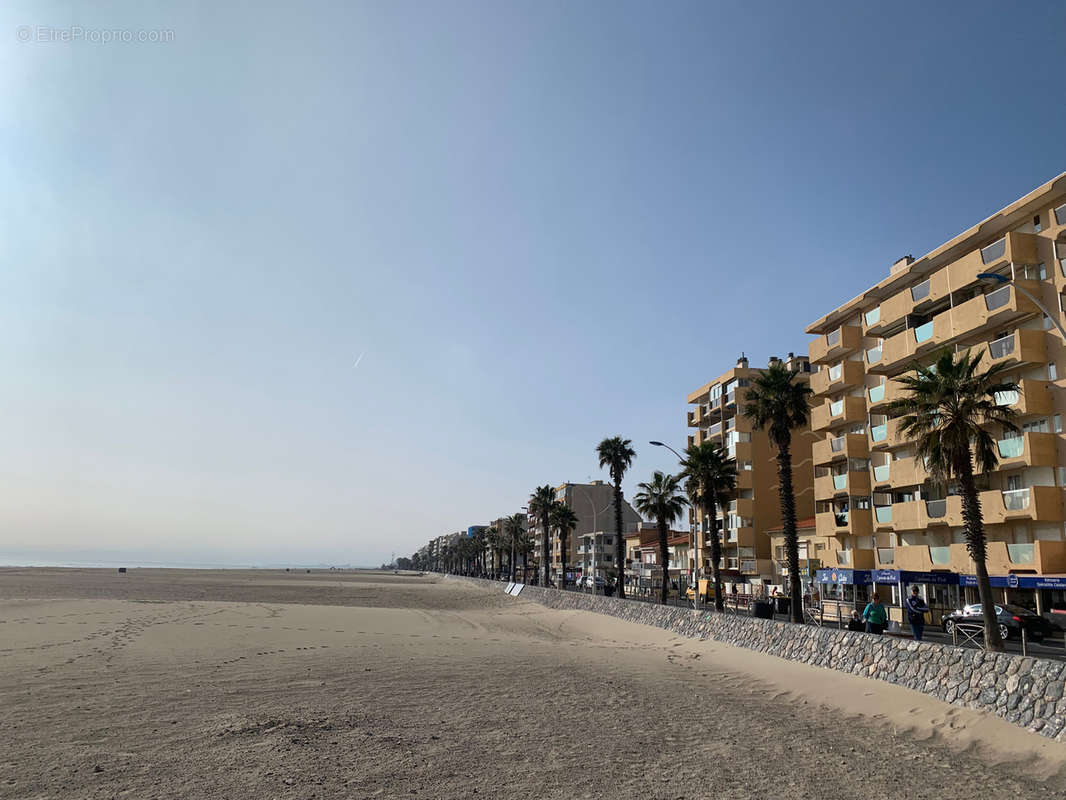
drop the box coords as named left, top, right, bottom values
left=688, top=353, right=814, bottom=583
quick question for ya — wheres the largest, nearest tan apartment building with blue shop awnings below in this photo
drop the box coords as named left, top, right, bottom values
left=807, top=174, right=1066, bottom=610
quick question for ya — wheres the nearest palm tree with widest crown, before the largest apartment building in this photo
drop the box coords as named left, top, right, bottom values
left=888, top=348, right=1018, bottom=651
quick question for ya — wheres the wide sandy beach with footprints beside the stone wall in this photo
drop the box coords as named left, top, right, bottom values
left=0, top=569, right=1066, bottom=800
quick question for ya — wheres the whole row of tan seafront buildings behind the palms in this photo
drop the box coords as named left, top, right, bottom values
left=424, top=173, right=1066, bottom=611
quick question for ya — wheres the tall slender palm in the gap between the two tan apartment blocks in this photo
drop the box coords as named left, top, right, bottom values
left=744, top=362, right=812, bottom=622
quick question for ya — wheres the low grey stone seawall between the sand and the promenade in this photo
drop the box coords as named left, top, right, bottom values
left=447, top=578, right=1066, bottom=741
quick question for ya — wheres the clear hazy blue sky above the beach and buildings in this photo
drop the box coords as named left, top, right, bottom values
left=0, top=0, right=1066, bottom=563
